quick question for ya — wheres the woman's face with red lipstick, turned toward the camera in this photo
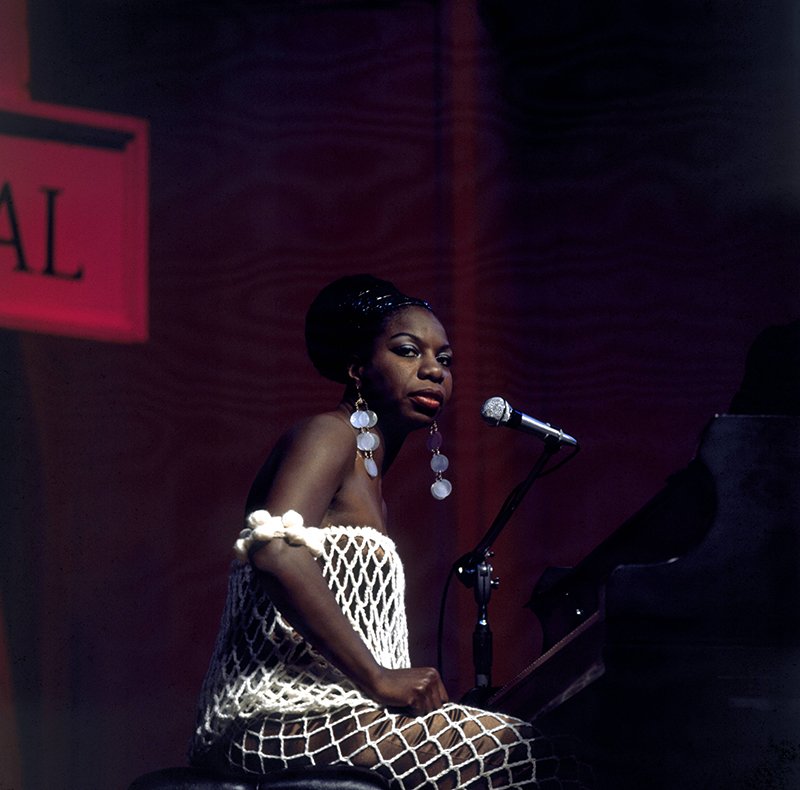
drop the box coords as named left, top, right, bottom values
left=358, top=307, right=453, bottom=428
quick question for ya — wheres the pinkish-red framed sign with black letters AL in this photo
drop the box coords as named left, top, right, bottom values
left=0, top=101, right=148, bottom=341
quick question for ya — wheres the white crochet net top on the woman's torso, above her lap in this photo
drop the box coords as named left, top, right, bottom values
left=193, top=527, right=409, bottom=750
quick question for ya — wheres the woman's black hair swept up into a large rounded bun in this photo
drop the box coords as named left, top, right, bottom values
left=306, top=274, right=431, bottom=384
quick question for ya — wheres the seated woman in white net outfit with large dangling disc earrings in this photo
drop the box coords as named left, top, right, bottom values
left=190, top=275, right=579, bottom=790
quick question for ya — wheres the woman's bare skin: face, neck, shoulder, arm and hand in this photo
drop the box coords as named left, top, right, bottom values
left=248, top=306, right=453, bottom=714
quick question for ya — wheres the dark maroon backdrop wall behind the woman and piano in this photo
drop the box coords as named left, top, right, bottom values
left=0, top=0, right=800, bottom=790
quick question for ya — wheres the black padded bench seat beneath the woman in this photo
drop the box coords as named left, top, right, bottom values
left=128, top=765, right=389, bottom=790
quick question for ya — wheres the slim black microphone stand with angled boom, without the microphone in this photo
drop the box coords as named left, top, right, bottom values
left=453, top=436, right=561, bottom=707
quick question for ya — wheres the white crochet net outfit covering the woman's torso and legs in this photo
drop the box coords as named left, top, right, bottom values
left=189, top=527, right=584, bottom=790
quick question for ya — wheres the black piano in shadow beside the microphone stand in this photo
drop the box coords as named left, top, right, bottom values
left=488, top=415, right=800, bottom=790
